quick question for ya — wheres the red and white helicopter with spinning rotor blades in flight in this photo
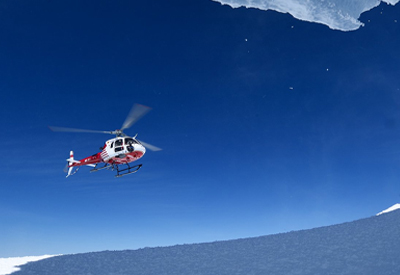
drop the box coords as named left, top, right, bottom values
left=49, top=104, right=161, bottom=178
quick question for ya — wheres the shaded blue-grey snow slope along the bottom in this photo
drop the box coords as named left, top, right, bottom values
left=13, top=210, right=400, bottom=275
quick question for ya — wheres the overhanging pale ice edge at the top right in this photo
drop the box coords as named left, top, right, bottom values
left=212, top=0, right=400, bottom=31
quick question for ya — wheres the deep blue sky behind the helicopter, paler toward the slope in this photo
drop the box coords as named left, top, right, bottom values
left=0, top=0, right=400, bottom=257
